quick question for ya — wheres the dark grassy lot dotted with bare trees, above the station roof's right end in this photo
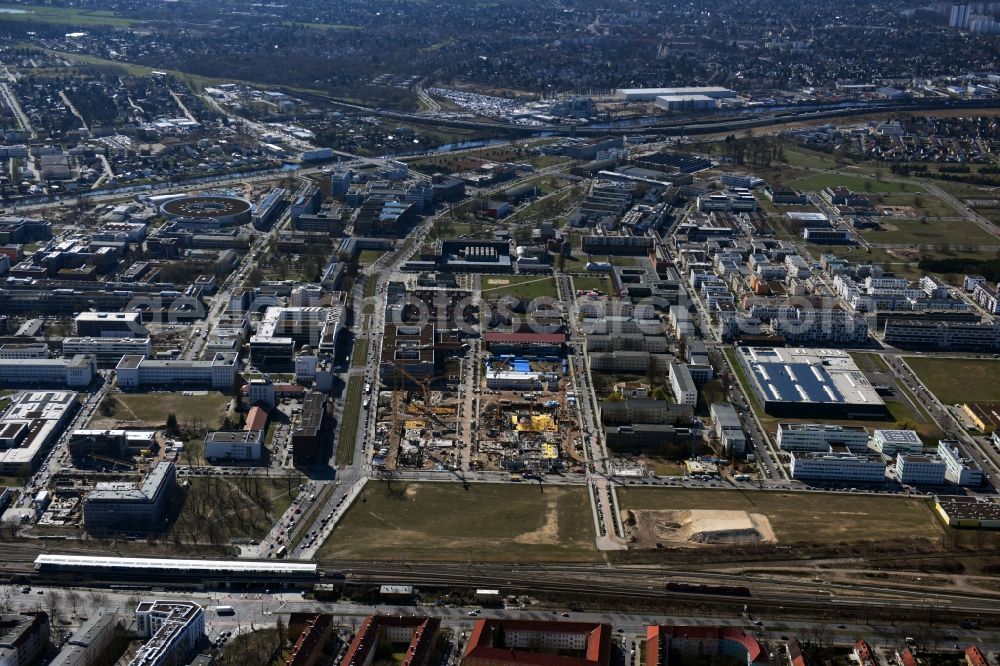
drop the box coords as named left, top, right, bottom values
left=170, top=476, right=300, bottom=545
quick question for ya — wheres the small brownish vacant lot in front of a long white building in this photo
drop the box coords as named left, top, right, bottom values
left=94, top=391, right=232, bottom=428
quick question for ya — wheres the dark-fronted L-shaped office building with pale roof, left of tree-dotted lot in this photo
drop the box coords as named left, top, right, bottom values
left=83, top=461, right=177, bottom=532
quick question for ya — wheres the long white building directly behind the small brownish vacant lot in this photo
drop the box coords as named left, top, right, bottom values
left=115, top=352, right=237, bottom=391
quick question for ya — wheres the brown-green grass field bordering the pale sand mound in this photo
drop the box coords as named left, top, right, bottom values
left=618, top=488, right=944, bottom=545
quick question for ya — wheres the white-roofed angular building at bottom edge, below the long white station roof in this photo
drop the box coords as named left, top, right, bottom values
left=128, top=600, right=205, bottom=666
